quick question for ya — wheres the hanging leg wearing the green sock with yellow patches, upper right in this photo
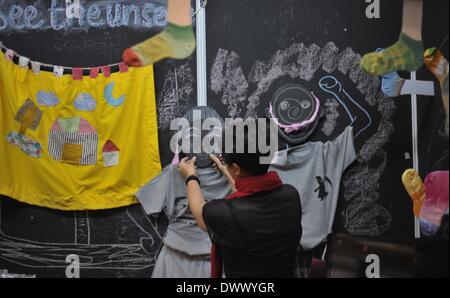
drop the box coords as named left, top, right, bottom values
left=361, top=0, right=424, bottom=76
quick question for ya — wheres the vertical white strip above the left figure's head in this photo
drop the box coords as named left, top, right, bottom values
left=196, top=0, right=208, bottom=107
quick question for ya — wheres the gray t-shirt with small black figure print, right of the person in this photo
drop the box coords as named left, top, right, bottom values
left=271, top=127, right=356, bottom=251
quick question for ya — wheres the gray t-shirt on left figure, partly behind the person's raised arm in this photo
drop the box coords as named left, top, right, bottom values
left=136, top=165, right=231, bottom=256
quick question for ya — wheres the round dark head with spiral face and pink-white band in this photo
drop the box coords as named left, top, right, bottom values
left=268, top=84, right=320, bottom=145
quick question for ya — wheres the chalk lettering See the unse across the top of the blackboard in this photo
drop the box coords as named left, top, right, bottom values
left=0, top=0, right=167, bottom=33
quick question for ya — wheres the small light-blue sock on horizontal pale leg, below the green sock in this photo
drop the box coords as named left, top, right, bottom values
left=381, top=72, right=434, bottom=97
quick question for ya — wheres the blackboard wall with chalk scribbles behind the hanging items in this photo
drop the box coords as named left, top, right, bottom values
left=0, top=0, right=448, bottom=277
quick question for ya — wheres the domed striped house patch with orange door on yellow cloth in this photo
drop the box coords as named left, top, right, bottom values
left=48, top=117, right=98, bottom=166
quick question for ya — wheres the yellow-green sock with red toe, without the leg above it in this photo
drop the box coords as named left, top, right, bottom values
left=123, top=22, right=195, bottom=67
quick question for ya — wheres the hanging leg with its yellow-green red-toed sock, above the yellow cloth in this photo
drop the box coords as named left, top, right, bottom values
left=123, top=0, right=195, bottom=67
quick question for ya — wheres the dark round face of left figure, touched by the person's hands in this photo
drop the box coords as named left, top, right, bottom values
left=179, top=107, right=225, bottom=168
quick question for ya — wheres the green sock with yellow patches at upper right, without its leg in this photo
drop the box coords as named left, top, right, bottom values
left=361, top=33, right=424, bottom=76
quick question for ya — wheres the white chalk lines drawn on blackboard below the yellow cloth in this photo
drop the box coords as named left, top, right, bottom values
left=0, top=201, right=162, bottom=270
